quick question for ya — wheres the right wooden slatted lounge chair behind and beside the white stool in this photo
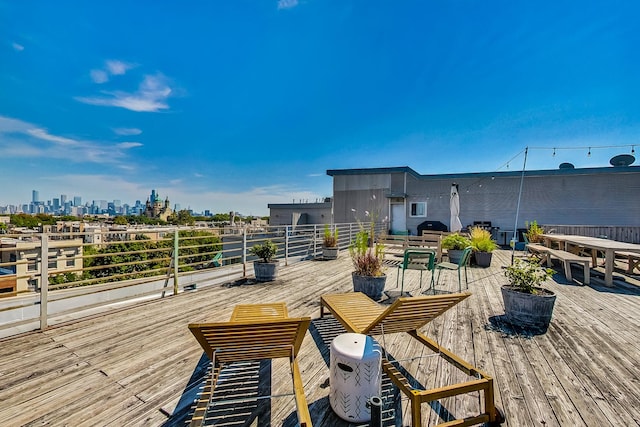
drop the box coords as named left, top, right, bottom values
left=320, top=292, right=504, bottom=427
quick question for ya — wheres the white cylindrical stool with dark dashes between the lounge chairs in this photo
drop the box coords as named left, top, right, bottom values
left=329, top=333, right=382, bottom=422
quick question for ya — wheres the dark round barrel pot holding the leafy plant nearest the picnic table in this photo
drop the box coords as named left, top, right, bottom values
left=501, top=285, right=556, bottom=331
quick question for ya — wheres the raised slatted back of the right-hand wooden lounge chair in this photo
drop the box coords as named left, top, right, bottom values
left=362, top=293, right=471, bottom=335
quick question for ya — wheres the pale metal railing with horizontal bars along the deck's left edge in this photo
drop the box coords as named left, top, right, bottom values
left=0, top=223, right=382, bottom=338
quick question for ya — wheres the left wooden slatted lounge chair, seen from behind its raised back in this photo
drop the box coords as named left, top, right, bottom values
left=189, top=303, right=312, bottom=427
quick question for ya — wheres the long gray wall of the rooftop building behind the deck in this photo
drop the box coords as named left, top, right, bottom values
left=327, top=166, right=640, bottom=234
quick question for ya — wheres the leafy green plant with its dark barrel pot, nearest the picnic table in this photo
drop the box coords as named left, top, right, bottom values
left=501, top=257, right=556, bottom=331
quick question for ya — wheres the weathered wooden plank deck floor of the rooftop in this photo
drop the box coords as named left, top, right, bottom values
left=0, top=251, right=640, bottom=426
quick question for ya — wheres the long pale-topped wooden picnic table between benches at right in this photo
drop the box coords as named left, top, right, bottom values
left=542, top=234, right=640, bottom=286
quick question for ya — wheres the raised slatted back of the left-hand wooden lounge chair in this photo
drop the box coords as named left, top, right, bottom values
left=189, top=317, right=311, bottom=363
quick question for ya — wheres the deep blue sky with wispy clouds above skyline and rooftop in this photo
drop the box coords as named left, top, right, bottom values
left=0, top=0, right=640, bottom=215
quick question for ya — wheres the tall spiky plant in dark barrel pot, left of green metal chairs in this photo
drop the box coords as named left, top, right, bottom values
left=349, top=229, right=387, bottom=301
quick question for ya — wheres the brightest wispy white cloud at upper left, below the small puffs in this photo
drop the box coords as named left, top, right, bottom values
left=75, top=74, right=171, bottom=112
